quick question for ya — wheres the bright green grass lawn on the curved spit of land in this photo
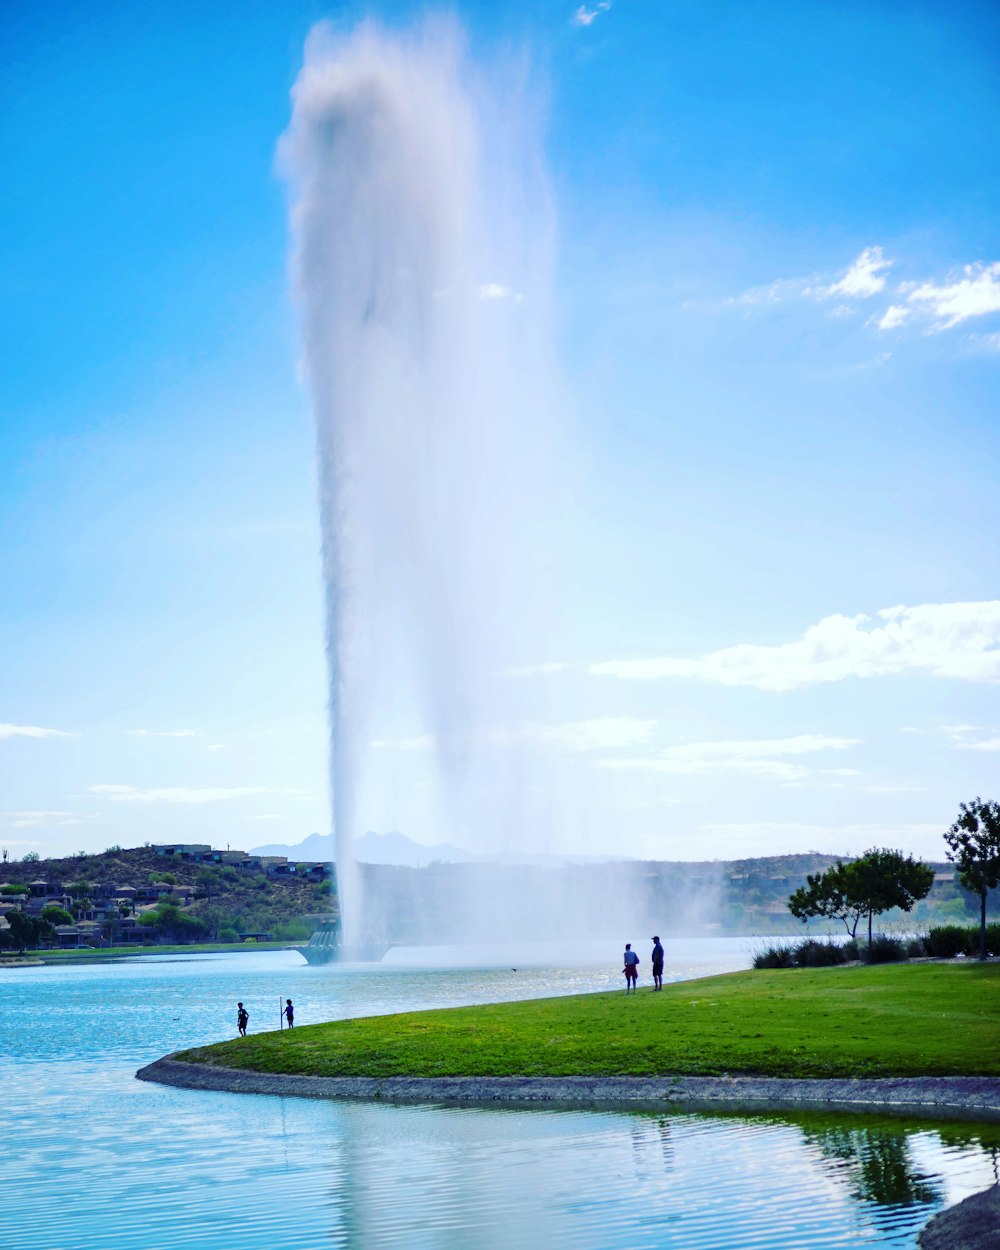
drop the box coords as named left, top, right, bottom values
left=181, top=963, right=1000, bottom=1078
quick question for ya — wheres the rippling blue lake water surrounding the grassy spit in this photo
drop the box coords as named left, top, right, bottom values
left=0, top=939, right=1000, bottom=1250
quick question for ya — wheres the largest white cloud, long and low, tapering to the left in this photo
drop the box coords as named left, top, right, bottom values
left=589, top=600, right=1000, bottom=690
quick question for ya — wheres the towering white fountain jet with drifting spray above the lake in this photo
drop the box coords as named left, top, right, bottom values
left=283, top=21, right=556, bottom=945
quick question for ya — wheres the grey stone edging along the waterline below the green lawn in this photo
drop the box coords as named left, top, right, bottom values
left=135, top=1055, right=1000, bottom=1123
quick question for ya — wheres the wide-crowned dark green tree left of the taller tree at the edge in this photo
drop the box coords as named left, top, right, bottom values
left=789, top=846, right=934, bottom=943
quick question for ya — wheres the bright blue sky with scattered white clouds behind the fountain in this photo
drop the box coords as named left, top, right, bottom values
left=0, top=0, right=1000, bottom=859
